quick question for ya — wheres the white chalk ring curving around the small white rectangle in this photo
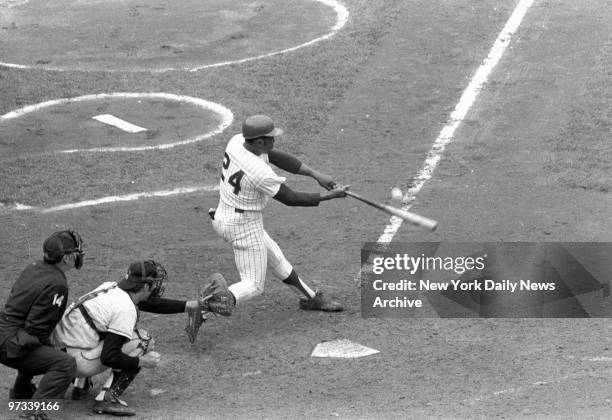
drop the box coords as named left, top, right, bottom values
left=0, top=92, right=234, bottom=153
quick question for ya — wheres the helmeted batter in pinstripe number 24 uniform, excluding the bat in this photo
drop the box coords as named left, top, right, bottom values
left=211, top=115, right=348, bottom=311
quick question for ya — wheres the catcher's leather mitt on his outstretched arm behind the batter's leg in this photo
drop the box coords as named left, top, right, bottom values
left=185, top=273, right=236, bottom=344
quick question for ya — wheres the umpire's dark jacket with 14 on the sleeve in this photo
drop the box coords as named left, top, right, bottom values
left=0, top=261, right=68, bottom=359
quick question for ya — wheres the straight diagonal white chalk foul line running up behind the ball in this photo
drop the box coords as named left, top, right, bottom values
left=377, top=0, right=533, bottom=244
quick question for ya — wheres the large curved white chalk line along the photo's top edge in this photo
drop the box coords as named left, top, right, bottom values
left=0, top=0, right=349, bottom=73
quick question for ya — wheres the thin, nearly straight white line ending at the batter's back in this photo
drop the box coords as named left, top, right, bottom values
left=12, top=185, right=219, bottom=213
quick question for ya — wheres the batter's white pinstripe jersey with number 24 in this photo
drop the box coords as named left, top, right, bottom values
left=219, top=134, right=286, bottom=210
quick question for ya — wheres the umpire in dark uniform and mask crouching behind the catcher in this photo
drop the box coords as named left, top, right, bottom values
left=0, top=230, right=84, bottom=399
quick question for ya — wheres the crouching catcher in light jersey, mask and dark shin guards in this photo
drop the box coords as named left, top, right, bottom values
left=53, top=260, right=215, bottom=416
